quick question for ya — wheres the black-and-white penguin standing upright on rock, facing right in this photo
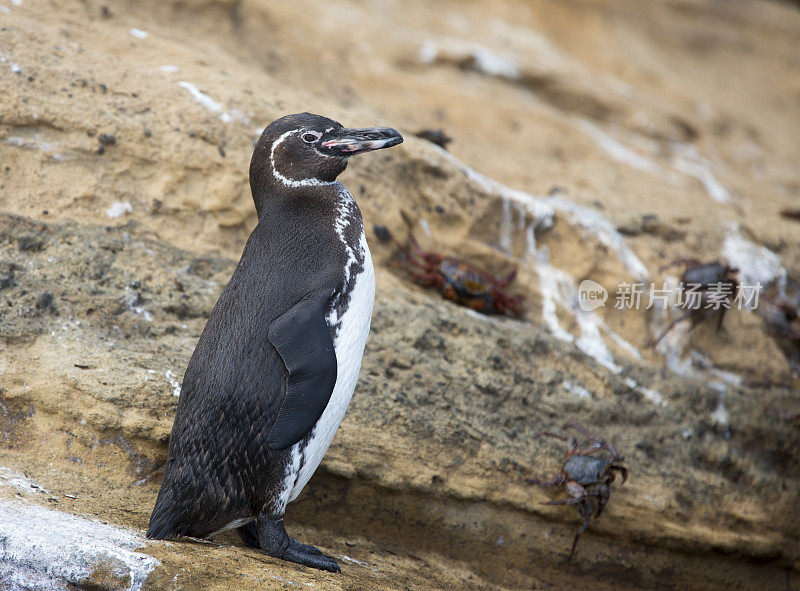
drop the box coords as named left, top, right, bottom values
left=147, top=113, right=403, bottom=572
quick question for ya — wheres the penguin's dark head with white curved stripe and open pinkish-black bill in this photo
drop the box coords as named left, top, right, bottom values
left=250, top=113, right=403, bottom=194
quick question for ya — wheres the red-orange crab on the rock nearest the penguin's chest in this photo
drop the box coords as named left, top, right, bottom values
left=398, top=234, right=524, bottom=316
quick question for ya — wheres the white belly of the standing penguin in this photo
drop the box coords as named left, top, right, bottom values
left=282, top=232, right=375, bottom=502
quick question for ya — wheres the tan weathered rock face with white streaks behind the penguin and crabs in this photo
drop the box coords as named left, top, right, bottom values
left=0, top=0, right=800, bottom=589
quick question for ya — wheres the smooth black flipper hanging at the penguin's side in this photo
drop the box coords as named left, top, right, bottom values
left=267, top=291, right=337, bottom=449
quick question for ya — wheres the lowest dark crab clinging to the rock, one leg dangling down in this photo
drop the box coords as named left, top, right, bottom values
left=525, top=423, right=628, bottom=560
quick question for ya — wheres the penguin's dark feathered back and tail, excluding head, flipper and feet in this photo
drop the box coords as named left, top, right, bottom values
left=147, top=195, right=346, bottom=539
